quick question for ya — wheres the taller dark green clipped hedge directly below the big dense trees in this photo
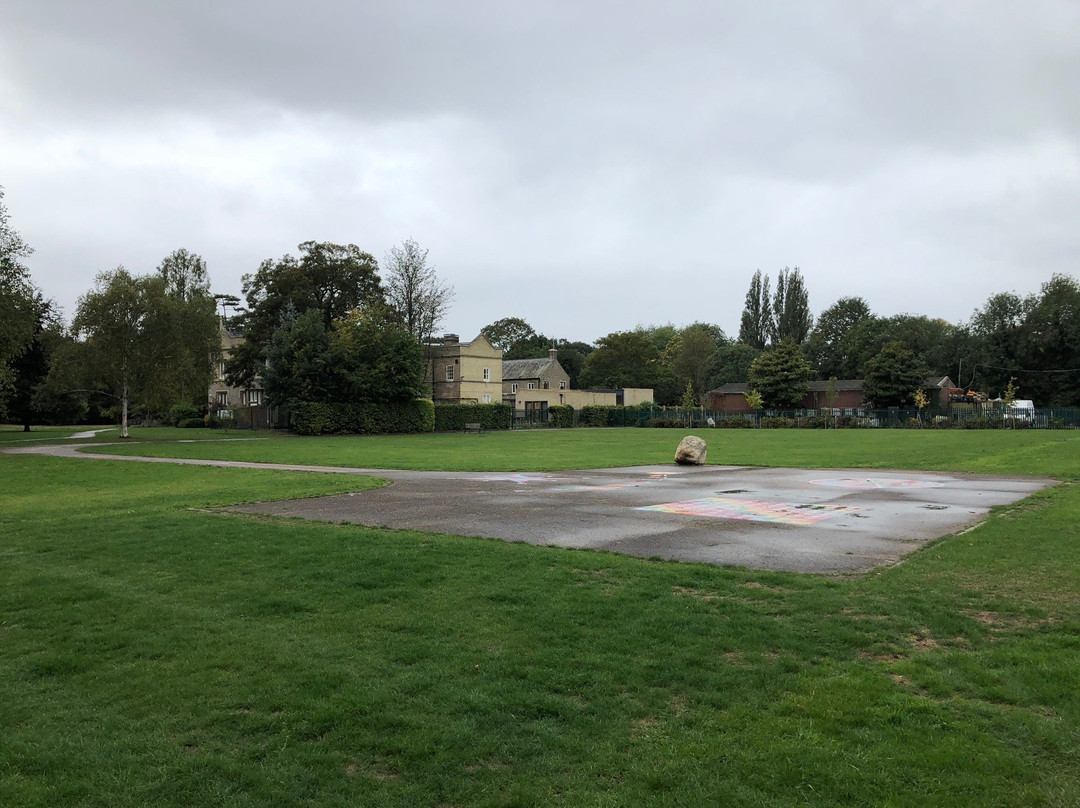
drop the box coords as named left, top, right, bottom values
left=291, top=399, right=435, bottom=435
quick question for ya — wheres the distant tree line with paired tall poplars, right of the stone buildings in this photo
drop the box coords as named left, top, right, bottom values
left=483, top=267, right=1080, bottom=408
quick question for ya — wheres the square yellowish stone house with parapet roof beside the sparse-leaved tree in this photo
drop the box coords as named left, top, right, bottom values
left=428, top=334, right=503, bottom=404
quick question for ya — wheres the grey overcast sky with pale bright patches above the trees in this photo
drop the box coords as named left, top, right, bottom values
left=0, top=0, right=1080, bottom=341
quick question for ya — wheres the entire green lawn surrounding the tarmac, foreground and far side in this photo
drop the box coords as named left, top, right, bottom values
left=6, top=430, right=1080, bottom=808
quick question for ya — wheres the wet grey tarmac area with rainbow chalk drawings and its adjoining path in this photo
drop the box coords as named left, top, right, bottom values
left=6, top=444, right=1053, bottom=573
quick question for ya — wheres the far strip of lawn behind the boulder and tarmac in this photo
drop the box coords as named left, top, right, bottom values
left=79, top=429, right=1080, bottom=476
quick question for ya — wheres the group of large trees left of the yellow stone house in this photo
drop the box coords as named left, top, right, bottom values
left=0, top=188, right=454, bottom=436
